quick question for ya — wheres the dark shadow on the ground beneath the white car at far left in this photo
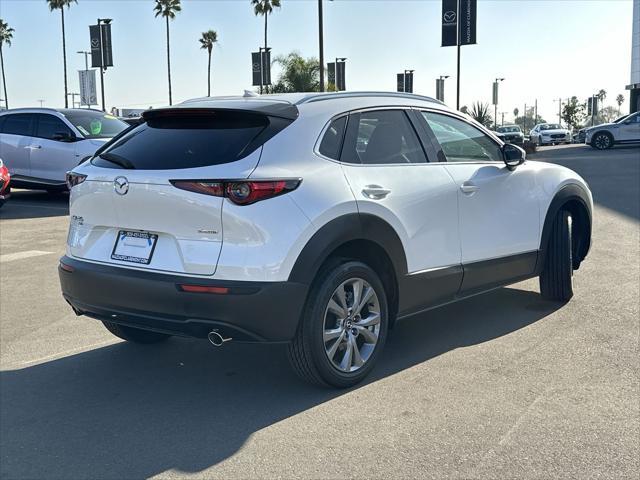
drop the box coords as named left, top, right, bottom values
left=0, top=190, right=69, bottom=220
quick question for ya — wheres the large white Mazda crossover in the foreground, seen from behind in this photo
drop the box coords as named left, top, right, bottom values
left=59, top=92, right=592, bottom=387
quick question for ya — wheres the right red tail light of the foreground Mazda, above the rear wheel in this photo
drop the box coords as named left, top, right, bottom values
left=171, top=178, right=302, bottom=205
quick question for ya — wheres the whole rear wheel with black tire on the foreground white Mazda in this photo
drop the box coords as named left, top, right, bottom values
left=288, top=261, right=389, bottom=388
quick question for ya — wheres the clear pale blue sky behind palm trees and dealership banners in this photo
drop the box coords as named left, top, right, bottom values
left=0, top=0, right=632, bottom=121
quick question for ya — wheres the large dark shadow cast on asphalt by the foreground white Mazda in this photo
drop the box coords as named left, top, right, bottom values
left=0, top=288, right=561, bottom=479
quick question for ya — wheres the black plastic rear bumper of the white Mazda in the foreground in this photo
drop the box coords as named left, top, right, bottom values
left=58, top=256, right=308, bottom=342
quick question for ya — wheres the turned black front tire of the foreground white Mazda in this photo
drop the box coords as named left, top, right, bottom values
left=540, top=210, right=573, bottom=302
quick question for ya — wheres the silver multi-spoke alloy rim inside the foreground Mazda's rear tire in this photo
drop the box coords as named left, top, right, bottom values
left=322, top=278, right=380, bottom=373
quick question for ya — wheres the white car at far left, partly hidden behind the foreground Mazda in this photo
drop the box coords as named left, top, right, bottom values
left=0, top=108, right=128, bottom=191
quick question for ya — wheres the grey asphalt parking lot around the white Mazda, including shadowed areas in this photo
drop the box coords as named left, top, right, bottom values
left=0, top=145, right=640, bottom=479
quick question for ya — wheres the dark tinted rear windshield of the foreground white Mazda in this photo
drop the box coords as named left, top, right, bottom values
left=93, top=111, right=269, bottom=170
